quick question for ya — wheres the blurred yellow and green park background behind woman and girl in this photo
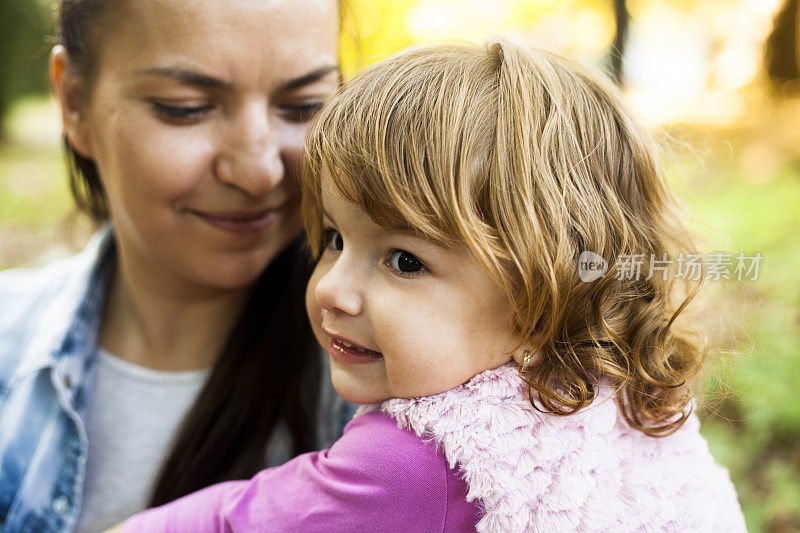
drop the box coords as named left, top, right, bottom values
left=0, top=0, right=800, bottom=532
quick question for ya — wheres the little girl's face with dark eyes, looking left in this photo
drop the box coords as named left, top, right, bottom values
left=306, top=177, right=515, bottom=403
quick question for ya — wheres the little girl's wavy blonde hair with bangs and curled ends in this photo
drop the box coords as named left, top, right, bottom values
left=303, top=40, right=705, bottom=436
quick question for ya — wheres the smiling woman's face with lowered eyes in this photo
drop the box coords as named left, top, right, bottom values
left=67, top=0, right=339, bottom=289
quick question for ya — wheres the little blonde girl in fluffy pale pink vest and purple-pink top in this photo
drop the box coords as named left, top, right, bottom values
left=117, top=41, right=744, bottom=532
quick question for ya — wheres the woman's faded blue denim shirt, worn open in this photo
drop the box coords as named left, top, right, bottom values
left=0, top=228, right=354, bottom=533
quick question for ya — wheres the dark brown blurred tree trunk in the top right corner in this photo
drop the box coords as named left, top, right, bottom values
left=764, top=0, right=800, bottom=90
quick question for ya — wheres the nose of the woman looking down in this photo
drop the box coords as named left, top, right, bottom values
left=214, top=106, right=285, bottom=196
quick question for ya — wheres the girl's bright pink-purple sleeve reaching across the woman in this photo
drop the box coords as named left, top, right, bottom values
left=124, top=412, right=466, bottom=533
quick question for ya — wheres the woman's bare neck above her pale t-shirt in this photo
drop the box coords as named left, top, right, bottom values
left=98, top=245, right=250, bottom=371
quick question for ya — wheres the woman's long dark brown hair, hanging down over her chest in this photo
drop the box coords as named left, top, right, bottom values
left=58, top=0, right=344, bottom=506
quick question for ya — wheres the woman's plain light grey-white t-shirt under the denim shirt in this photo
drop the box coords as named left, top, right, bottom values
left=77, top=349, right=211, bottom=533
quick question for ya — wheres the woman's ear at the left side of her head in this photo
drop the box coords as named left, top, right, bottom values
left=50, top=44, right=92, bottom=159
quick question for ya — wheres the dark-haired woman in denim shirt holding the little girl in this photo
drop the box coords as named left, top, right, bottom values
left=0, top=0, right=346, bottom=532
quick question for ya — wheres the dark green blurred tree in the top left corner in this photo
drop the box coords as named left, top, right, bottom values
left=0, top=0, right=54, bottom=138
